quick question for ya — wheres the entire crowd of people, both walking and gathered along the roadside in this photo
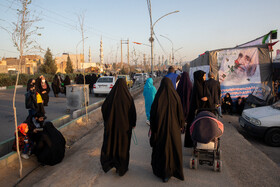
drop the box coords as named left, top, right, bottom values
left=13, top=67, right=247, bottom=182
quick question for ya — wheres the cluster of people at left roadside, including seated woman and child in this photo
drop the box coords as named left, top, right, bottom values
left=13, top=75, right=66, bottom=165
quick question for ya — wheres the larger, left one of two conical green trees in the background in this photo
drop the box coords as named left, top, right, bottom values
left=40, top=48, right=57, bottom=75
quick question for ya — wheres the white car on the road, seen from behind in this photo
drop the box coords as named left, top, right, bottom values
left=93, top=76, right=116, bottom=96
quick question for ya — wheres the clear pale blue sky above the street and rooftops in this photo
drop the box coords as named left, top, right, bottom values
left=0, top=0, right=280, bottom=63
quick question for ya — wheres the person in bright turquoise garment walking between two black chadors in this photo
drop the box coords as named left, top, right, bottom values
left=143, top=78, right=157, bottom=125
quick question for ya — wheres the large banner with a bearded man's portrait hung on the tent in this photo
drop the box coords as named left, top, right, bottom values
left=217, top=48, right=261, bottom=99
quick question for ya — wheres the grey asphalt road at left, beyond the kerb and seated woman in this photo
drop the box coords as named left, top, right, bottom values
left=0, top=88, right=105, bottom=142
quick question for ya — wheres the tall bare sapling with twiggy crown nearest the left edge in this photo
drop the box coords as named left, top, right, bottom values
left=1, top=0, right=40, bottom=177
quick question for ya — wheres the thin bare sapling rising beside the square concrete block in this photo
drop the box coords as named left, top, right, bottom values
left=78, top=13, right=88, bottom=122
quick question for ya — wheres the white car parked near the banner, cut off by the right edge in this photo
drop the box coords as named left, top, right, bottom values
left=239, top=101, right=280, bottom=147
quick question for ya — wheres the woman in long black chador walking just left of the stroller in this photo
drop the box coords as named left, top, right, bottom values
left=150, top=77, right=185, bottom=182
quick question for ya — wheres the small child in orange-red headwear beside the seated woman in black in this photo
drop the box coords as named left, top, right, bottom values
left=13, top=123, right=31, bottom=159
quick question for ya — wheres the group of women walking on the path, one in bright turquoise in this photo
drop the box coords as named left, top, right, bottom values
left=101, top=71, right=211, bottom=182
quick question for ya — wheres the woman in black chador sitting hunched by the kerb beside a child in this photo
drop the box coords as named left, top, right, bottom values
left=35, top=122, right=66, bottom=166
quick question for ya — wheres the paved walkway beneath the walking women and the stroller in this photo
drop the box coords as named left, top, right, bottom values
left=0, top=95, right=280, bottom=186
